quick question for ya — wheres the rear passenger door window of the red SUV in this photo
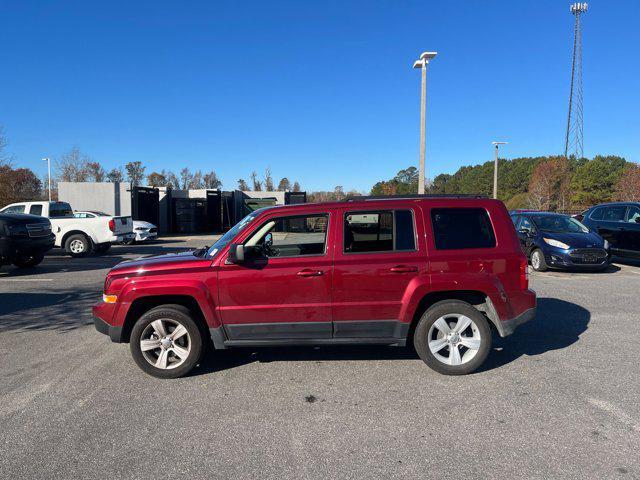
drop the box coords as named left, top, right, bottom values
left=344, top=210, right=416, bottom=253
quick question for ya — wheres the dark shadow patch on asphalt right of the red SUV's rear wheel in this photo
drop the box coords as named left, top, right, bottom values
left=479, top=298, right=591, bottom=371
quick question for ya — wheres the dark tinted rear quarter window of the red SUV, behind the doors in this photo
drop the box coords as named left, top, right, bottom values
left=431, top=208, right=496, bottom=250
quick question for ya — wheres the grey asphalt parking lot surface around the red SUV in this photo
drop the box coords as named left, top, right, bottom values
left=0, top=237, right=640, bottom=479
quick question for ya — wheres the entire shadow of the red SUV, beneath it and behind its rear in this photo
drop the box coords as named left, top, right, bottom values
left=191, top=298, right=591, bottom=375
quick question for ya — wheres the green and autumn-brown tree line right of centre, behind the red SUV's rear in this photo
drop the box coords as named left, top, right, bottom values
left=371, top=155, right=640, bottom=211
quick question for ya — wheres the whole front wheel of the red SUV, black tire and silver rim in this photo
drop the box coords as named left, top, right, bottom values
left=130, top=305, right=203, bottom=378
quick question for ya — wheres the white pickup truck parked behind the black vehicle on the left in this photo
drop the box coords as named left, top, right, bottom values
left=0, top=202, right=135, bottom=257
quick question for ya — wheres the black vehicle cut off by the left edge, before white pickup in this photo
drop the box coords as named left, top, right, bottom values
left=0, top=213, right=56, bottom=268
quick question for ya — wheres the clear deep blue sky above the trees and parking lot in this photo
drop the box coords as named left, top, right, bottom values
left=0, top=0, right=640, bottom=191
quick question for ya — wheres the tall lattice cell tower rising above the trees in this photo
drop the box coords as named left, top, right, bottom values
left=564, top=2, right=589, bottom=158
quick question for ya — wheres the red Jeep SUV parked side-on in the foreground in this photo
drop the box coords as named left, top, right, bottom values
left=93, top=196, right=536, bottom=378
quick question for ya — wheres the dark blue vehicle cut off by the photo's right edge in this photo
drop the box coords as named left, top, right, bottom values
left=577, top=202, right=640, bottom=258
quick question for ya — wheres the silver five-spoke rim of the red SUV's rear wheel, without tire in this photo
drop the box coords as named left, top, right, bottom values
left=428, top=313, right=482, bottom=365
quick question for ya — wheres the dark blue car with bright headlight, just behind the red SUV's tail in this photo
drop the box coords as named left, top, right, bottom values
left=511, top=212, right=610, bottom=272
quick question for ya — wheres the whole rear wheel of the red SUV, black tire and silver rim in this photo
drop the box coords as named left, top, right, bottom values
left=413, top=300, right=491, bottom=375
